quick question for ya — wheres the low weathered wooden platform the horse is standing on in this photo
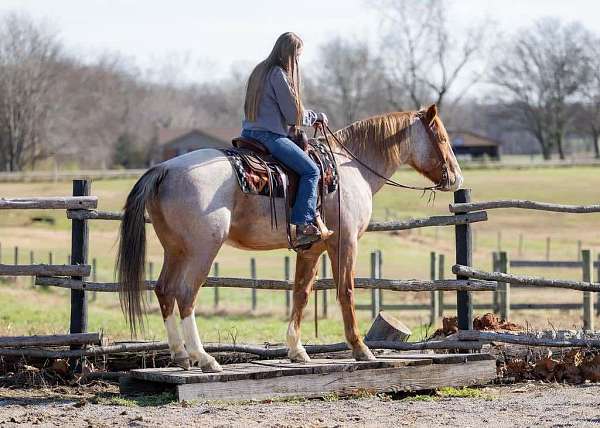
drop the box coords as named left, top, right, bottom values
left=120, top=354, right=496, bottom=401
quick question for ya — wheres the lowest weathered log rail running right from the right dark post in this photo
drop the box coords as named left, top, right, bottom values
left=458, top=330, right=600, bottom=348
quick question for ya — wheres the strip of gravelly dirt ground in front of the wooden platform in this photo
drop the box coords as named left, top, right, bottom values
left=0, top=382, right=600, bottom=428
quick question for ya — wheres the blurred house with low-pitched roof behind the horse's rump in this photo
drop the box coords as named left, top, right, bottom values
left=157, top=127, right=241, bottom=161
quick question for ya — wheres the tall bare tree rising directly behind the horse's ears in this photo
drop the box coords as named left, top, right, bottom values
left=372, top=0, right=489, bottom=110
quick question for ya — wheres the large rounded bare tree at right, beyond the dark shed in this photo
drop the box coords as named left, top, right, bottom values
left=492, top=18, right=589, bottom=159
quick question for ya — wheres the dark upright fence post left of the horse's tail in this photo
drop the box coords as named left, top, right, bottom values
left=69, top=180, right=91, bottom=340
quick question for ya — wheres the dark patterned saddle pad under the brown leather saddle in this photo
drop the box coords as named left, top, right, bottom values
left=219, top=140, right=338, bottom=198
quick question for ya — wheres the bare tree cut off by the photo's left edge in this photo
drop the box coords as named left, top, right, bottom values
left=0, top=14, right=61, bottom=171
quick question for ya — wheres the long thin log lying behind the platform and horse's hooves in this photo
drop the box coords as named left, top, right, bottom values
left=0, top=339, right=482, bottom=358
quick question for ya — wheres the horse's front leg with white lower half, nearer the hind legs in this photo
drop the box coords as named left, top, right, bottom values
left=286, top=245, right=324, bottom=362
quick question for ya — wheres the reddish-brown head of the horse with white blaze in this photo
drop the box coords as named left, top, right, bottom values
left=409, top=104, right=463, bottom=192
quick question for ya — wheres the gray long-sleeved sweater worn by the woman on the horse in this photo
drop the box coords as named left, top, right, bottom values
left=242, top=66, right=317, bottom=135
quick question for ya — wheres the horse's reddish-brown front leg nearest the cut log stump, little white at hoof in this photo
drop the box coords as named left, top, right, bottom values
left=327, top=239, right=375, bottom=361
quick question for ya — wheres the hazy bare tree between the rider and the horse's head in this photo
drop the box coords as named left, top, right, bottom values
left=307, top=37, right=381, bottom=125
